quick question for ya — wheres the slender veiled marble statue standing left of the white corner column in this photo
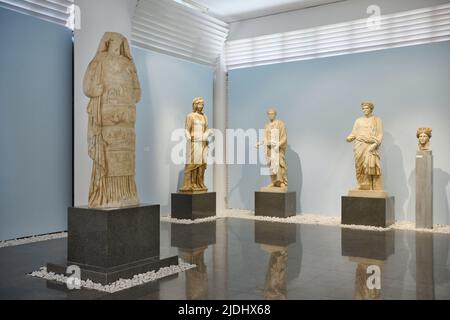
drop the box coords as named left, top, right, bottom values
left=180, top=97, right=212, bottom=193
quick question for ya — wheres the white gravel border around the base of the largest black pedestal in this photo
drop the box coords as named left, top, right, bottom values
left=29, top=261, right=197, bottom=293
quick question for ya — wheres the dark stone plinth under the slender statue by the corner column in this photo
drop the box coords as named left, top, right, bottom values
left=172, top=192, right=216, bottom=220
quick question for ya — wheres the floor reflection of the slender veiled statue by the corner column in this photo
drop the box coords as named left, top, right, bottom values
left=179, top=247, right=208, bottom=300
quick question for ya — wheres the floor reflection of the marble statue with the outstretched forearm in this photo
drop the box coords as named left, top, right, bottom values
left=261, top=245, right=288, bottom=300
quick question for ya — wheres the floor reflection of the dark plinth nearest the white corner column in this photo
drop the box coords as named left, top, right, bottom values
left=171, top=221, right=216, bottom=249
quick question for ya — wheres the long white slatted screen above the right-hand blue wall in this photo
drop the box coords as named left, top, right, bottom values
left=225, top=4, right=450, bottom=70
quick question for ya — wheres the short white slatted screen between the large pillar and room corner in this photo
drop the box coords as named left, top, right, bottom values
left=131, top=0, right=229, bottom=66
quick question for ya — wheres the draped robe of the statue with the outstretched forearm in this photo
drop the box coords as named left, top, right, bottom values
left=264, top=120, right=288, bottom=186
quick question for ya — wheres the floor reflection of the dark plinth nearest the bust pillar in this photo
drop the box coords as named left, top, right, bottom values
left=341, top=228, right=395, bottom=261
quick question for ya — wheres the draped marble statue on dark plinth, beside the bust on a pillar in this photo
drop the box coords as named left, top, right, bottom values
left=347, top=102, right=384, bottom=195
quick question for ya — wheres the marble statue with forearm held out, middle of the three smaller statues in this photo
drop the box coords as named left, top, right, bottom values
left=256, top=109, right=288, bottom=192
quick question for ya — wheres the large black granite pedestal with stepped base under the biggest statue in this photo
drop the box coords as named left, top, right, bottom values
left=47, top=205, right=178, bottom=284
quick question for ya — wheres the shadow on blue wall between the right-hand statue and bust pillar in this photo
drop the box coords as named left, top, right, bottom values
left=381, top=132, right=409, bottom=220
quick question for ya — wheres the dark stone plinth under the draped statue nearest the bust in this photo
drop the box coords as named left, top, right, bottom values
left=342, top=197, right=395, bottom=228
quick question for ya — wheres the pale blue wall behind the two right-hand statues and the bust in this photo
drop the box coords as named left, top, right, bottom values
left=229, top=42, right=450, bottom=224
